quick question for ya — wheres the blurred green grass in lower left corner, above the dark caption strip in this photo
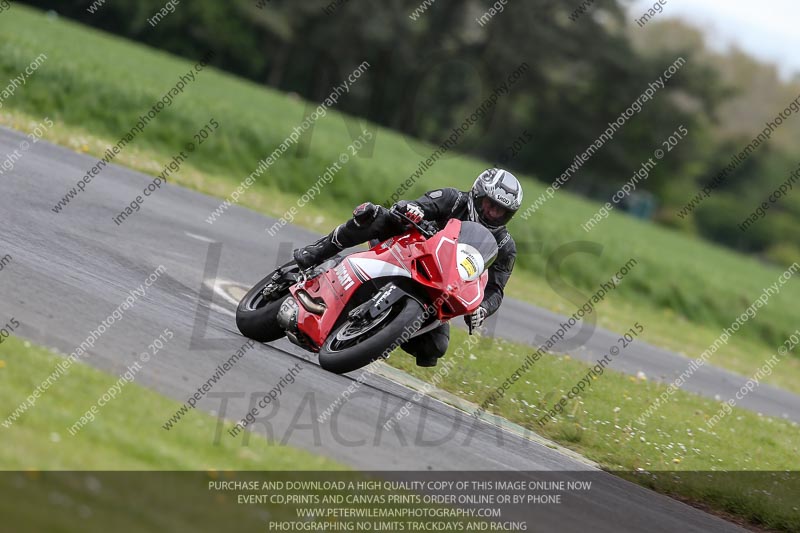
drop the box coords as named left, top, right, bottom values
left=0, top=337, right=344, bottom=471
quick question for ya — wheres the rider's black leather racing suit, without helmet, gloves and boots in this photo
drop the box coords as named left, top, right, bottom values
left=331, top=188, right=517, bottom=357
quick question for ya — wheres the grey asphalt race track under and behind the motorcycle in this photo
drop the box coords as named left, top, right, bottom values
left=0, top=129, right=768, bottom=532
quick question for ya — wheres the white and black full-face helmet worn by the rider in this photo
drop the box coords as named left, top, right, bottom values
left=469, top=168, right=522, bottom=230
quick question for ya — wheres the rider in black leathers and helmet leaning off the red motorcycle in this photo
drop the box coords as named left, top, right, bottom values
left=293, top=168, right=522, bottom=367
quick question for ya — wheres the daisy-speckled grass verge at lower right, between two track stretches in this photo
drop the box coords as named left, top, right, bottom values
left=388, top=330, right=800, bottom=531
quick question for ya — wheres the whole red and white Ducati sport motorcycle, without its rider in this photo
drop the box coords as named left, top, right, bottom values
left=236, top=211, right=497, bottom=374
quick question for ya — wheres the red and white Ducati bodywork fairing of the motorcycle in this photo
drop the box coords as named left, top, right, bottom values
left=291, top=219, right=488, bottom=347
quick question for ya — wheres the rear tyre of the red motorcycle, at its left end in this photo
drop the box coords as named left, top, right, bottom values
left=236, top=274, right=289, bottom=342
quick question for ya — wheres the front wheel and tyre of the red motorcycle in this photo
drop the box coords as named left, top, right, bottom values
left=319, top=298, right=423, bottom=374
